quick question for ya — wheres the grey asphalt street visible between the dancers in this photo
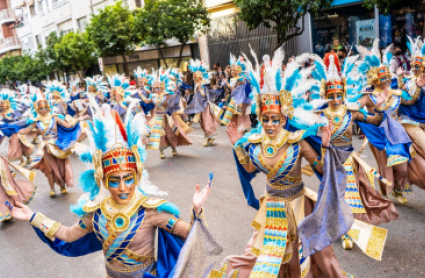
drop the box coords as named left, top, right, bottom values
left=0, top=125, right=425, bottom=278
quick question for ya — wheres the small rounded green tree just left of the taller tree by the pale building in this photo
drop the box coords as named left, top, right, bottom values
left=53, top=32, right=97, bottom=80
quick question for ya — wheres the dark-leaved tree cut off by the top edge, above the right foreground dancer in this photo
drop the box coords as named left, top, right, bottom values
left=233, top=0, right=333, bottom=49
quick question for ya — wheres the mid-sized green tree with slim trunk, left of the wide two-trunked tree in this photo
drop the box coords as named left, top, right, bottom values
left=86, top=1, right=141, bottom=76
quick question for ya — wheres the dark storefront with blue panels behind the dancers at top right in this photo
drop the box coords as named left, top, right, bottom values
left=310, top=0, right=425, bottom=56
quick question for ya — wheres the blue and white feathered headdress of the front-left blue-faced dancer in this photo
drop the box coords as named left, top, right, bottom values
left=72, top=95, right=151, bottom=213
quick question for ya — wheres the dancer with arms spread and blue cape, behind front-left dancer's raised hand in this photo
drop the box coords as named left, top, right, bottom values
left=18, top=91, right=85, bottom=197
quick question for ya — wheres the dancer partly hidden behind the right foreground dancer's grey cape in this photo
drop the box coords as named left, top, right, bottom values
left=306, top=55, right=398, bottom=260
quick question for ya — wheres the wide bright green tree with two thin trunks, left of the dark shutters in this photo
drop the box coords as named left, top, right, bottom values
left=135, top=0, right=210, bottom=66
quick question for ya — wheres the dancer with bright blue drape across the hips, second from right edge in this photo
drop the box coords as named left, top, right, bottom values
left=353, top=39, right=412, bottom=204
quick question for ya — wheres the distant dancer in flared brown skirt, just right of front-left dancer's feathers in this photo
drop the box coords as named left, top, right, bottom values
left=145, top=69, right=192, bottom=159
